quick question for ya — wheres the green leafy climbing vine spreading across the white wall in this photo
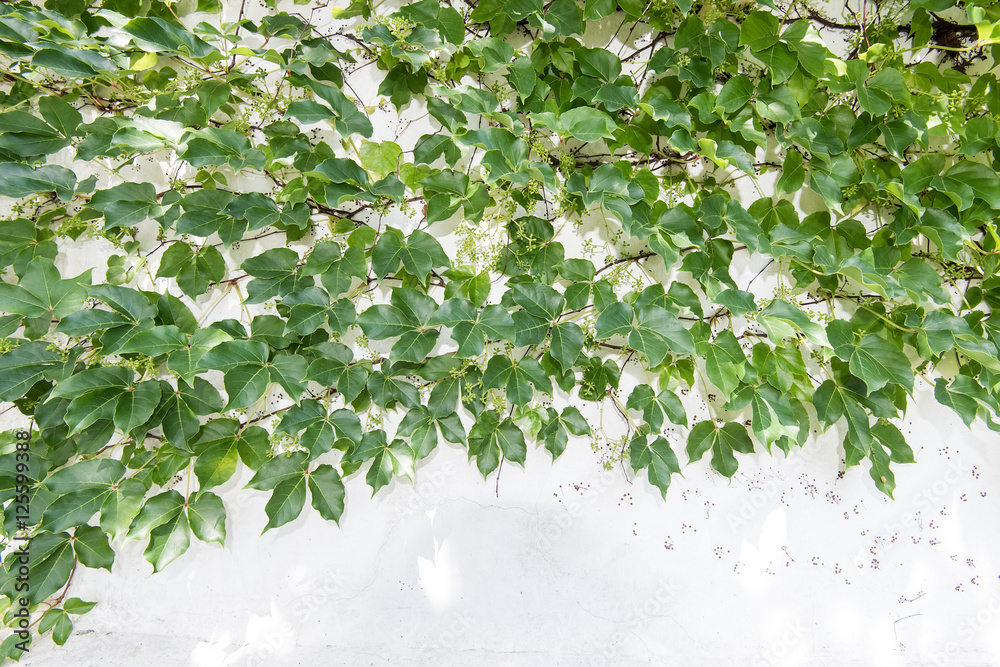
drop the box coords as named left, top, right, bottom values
left=0, top=0, right=1000, bottom=658
